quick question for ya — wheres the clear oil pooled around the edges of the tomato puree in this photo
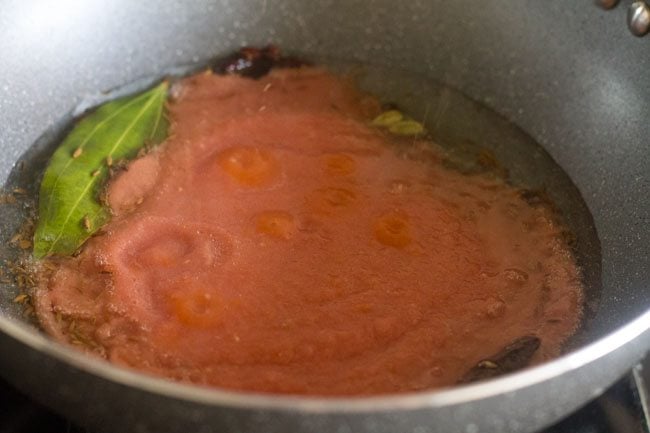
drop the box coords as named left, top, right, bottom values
left=0, top=55, right=601, bottom=356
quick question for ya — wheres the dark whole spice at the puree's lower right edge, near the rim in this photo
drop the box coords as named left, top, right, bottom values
left=458, top=335, right=540, bottom=383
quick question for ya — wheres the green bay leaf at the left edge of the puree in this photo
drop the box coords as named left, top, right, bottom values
left=34, top=82, right=168, bottom=258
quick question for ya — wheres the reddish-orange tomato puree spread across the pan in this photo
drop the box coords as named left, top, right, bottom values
left=36, top=67, right=581, bottom=395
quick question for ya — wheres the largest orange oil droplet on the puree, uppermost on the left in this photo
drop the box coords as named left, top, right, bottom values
left=217, top=147, right=280, bottom=187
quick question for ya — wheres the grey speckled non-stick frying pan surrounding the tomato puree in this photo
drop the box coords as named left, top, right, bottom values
left=0, top=0, right=650, bottom=433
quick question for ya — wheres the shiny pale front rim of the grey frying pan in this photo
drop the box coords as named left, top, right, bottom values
left=0, top=309, right=650, bottom=414
